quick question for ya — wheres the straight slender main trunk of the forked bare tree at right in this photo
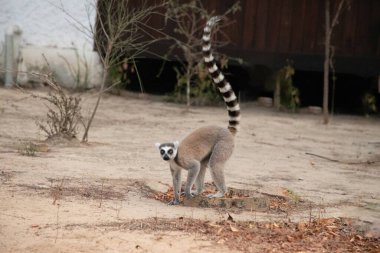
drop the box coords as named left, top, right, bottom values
left=323, top=0, right=332, bottom=124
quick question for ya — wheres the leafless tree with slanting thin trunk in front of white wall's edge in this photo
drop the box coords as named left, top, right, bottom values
left=57, top=0, right=164, bottom=142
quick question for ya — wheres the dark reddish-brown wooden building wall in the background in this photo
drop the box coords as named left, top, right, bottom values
left=96, top=0, right=380, bottom=110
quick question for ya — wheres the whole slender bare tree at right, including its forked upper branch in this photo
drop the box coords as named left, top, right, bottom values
left=323, top=0, right=350, bottom=124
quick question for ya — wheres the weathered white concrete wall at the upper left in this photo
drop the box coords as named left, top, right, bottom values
left=0, top=0, right=102, bottom=87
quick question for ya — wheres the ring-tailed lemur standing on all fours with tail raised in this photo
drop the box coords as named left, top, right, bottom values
left=156, top=17, right=240, bottom=205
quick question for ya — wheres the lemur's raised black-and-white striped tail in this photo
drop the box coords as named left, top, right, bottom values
left=202, top=16, right=240, bottom=134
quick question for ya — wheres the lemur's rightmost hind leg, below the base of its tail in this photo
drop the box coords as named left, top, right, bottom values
left=208, top=138, right=234, bottom=198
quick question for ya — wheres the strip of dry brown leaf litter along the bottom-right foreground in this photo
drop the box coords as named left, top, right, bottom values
left=63, top=216, right=380, bottom=253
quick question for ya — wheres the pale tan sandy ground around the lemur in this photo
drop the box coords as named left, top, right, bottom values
left=0, top=89, right=380, bottom=252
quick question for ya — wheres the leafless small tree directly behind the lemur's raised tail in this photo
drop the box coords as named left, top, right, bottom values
left=165, top=0, right=240, bottom=108
